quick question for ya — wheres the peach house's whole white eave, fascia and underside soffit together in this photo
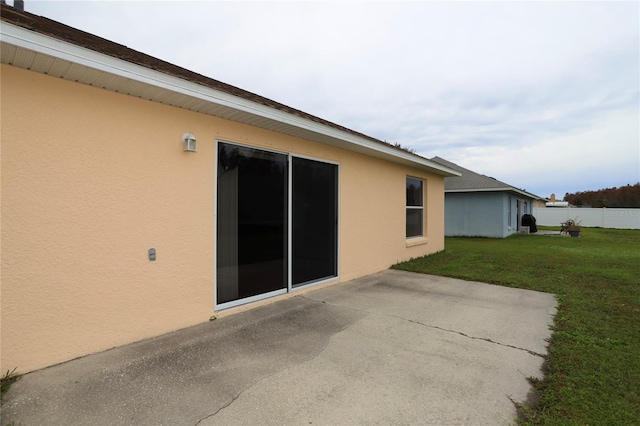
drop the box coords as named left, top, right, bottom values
left=1, top=22, right=460, bottom=176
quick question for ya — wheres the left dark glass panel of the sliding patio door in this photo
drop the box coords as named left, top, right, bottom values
left=216, top=143, right=288, bottom=304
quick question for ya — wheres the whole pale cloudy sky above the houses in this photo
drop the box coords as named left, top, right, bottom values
left=13, top=0, right=640, bottom=198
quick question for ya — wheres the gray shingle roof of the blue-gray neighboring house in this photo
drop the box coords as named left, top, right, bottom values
left=431, top=157, right=542, bottom=199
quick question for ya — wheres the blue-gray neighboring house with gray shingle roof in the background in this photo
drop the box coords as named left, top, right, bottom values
left=431, top=157, right=540, bottom=238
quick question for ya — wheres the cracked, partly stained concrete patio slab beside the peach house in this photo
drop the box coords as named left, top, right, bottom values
left=2, top=270, right=556, bottom=425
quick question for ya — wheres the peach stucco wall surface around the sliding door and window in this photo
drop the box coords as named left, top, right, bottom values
left=0, top=65, right=444, bottom=372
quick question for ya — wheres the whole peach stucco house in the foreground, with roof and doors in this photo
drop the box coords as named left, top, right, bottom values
left=0, top=4, right=457, bottom=373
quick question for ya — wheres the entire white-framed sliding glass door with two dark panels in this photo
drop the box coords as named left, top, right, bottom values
left=216, top=142, right=338, bottom=308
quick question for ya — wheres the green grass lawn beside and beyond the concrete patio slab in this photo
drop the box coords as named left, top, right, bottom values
left=394, top=228, right=640, bottom=425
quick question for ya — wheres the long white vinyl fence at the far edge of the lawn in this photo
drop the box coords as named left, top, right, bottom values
left=533, top=207, right=640, bottom=229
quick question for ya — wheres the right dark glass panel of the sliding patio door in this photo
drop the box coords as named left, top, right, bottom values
left=291, top=157, right=338, bottom=287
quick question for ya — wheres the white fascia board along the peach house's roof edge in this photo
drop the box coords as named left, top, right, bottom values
left=0, top=22, right=460, bottom=176
